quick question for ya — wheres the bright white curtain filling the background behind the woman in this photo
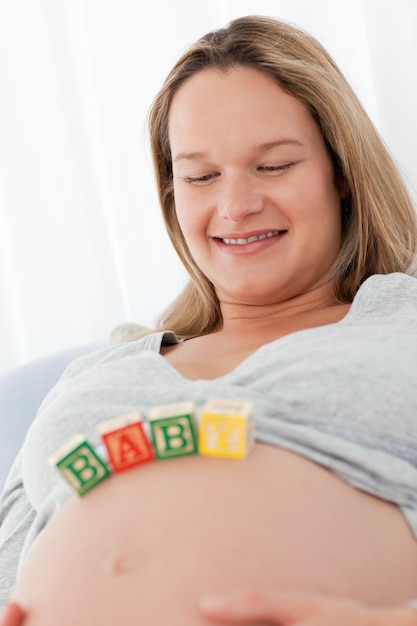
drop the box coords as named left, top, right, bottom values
left=0, top=0, right=417, bottom=374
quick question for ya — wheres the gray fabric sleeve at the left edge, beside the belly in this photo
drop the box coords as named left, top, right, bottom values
left=0, top=453, right=36, bottom=607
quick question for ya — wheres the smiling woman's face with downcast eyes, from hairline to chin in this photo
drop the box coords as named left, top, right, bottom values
left=169, top=67, right=341, bottom=304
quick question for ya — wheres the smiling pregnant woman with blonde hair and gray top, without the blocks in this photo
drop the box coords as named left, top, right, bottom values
left=0, top=17, right=417, bottom=626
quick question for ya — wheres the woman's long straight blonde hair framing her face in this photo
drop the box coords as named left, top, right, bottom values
left=149, top=16, right=417, bottom=338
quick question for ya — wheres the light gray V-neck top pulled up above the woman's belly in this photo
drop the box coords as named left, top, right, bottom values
left=0, top=274, right=417, bottom=604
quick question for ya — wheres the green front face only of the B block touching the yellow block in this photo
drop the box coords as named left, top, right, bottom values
left=150, top=414, right=198, bottom=459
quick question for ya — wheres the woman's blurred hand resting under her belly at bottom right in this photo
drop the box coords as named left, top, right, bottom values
left=200, top=589, right=417, bottom=626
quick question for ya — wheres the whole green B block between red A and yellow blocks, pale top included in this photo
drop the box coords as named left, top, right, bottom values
left=148, top=402, right=198, bottom=459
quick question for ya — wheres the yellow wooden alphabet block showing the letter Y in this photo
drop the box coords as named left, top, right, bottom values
left=198, top=398, right=255, bottom=459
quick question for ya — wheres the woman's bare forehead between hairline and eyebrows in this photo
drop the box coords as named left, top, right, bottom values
left=168, top=67, right=318, bottom=150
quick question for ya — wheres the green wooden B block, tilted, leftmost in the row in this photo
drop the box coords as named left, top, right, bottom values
left=49, top=435, right=111, bottom=496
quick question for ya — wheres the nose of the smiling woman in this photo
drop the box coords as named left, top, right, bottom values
left=217, top=177, right=264, bottom=222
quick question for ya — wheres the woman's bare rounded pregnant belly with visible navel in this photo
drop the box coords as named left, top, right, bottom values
left=15, top=444, right=417, bottom=626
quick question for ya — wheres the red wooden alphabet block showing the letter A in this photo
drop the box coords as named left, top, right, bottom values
left=98, top=412, right=155, bottom=473
